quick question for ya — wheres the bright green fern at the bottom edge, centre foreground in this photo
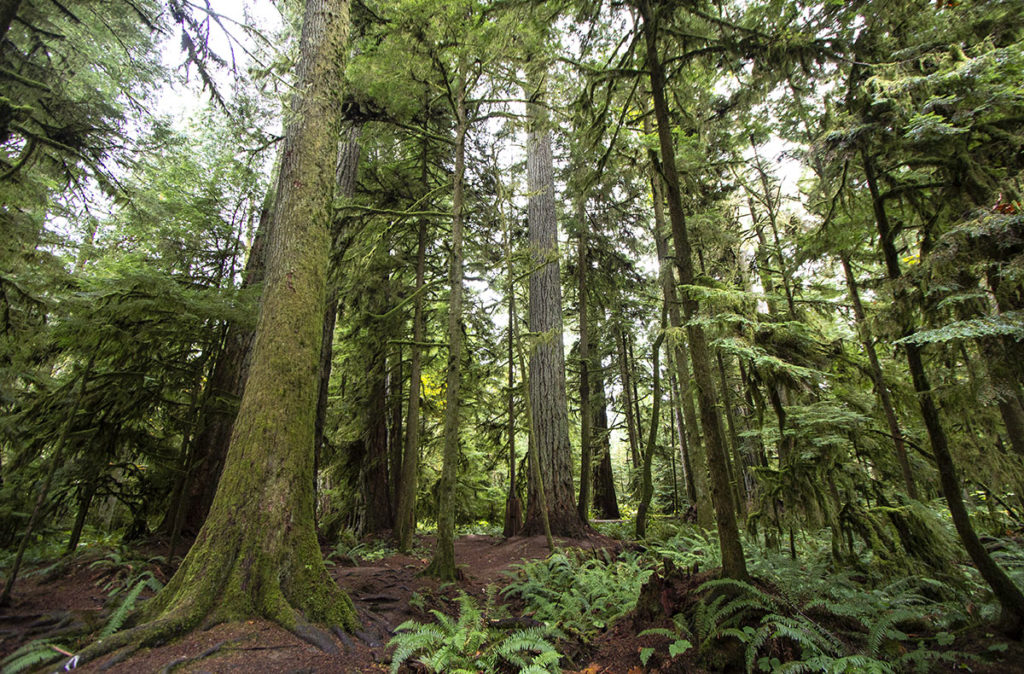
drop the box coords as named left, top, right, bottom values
left=389, top=593, right=561, bottom=674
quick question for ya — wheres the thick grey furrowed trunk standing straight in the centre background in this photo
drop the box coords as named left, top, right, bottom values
left=523, top=62, right=586, bottom=538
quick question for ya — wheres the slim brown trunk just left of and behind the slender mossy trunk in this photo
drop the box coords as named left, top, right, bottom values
left=394, top=219, right=427, bottom=552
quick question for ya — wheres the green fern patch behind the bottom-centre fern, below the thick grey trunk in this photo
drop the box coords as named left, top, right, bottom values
left=502, top=551, right=651, bottom=641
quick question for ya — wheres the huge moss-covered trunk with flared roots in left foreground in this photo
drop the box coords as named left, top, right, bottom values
left=68, top=0, right=356, bottom=660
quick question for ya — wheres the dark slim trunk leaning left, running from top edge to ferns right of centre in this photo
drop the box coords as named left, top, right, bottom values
left=639, top=0, right=748, bottom=579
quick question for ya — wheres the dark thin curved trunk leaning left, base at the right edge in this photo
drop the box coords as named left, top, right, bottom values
left=861, top=151, right=1024, bottom=636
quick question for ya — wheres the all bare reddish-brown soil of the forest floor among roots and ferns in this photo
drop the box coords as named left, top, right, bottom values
left=0, top=535, right=1024, bottom=674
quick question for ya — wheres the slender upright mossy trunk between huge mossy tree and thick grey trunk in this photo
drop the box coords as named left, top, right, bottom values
left=424, top=58, right=469, bottom=581
